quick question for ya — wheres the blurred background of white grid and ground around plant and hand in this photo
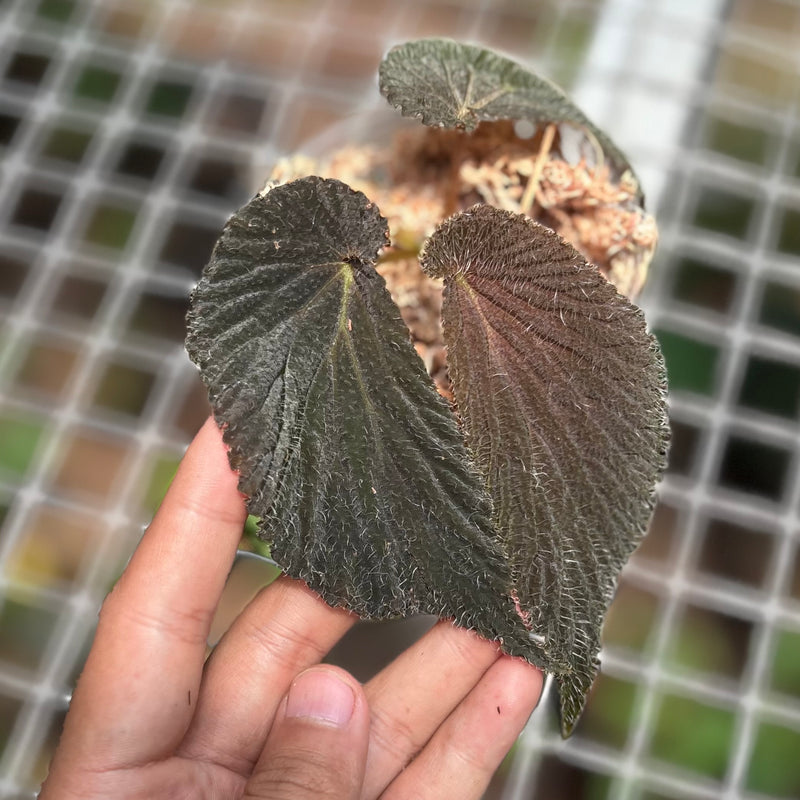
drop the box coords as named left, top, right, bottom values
left=0, top=0, right=800, bottom=800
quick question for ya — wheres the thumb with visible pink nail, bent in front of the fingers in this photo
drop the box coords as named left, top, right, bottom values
left=243, top=666, right=369, bottom=800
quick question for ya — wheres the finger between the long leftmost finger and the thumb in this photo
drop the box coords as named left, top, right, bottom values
left=179, top=577, right=357, bottom=776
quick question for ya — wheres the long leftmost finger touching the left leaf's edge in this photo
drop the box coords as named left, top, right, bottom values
left=57, top=420, right=246, bottom=769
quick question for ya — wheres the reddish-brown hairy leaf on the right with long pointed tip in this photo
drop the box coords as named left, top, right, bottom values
left=422, top=205, right=668, bottom=735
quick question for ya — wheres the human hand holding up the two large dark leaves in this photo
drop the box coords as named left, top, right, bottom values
left=40, top=420, right=542, bottom=800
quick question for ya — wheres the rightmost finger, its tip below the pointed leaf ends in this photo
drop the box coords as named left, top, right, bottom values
left=382, top=656, right=542, bottom=800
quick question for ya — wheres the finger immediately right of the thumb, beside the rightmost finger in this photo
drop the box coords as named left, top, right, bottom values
left=362, top=621, right=500, bottom=798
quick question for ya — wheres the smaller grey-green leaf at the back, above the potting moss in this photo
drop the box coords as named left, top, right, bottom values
left=379, top=39, right=632, bottom=180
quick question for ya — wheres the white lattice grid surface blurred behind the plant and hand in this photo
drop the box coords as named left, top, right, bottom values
left=0, top=0, right=800, bottom=798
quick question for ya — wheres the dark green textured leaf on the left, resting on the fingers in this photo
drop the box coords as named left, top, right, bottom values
left=187, top=178, right=529, bottom=652
